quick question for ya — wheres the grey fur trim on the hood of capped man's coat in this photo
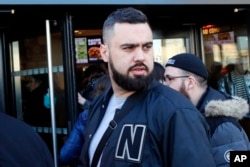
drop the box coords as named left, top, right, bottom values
left=205, top=97, right=249, bottom=119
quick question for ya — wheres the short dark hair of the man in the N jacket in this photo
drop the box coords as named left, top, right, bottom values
left=102, top=7, right=148, bottom=43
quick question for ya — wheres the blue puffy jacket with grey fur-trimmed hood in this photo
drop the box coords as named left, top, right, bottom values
left=197, top=88, right=250, bottom=167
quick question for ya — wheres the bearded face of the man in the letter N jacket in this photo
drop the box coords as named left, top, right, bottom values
left=101, top=23, right=154, bottom=91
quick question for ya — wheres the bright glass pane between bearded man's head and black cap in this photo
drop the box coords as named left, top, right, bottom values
left=153, top=25, right=200, bottom=66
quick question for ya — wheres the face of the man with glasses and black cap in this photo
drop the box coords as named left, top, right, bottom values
left=164, top=66, right=189, bottom=98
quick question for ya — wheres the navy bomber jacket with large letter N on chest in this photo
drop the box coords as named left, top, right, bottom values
left=79, top=81, right=215, bottom=167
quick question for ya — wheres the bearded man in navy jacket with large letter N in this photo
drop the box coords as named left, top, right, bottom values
left=79, top=8, right=215, bottom=167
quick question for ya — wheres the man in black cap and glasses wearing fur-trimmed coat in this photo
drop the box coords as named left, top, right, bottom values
left=164, top=53, right=250, bottom=166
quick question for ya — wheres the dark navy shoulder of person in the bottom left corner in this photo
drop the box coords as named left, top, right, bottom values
left=0, top=112, right=54, bottom=167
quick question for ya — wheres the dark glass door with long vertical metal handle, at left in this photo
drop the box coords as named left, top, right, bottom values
left=6, top=9, right=67, bottom=166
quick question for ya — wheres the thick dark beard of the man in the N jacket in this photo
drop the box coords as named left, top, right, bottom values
left=110, top=57, right=153, bottom=91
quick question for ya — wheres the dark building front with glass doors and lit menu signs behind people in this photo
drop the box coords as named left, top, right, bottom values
left=0, top=0, right=250, bottom=165
